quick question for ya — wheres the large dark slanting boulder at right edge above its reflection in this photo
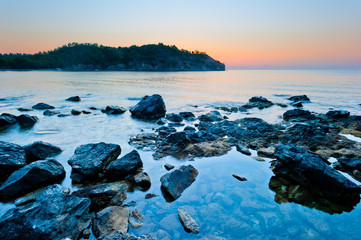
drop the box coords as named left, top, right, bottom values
left=272, top=145, right=361, bottom=202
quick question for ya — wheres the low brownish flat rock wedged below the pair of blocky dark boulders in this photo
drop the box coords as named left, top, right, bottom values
left=72, top=182, right=128, bottom=212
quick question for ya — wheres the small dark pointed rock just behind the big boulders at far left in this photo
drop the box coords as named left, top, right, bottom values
left=24, top=141, right=62, bottom=163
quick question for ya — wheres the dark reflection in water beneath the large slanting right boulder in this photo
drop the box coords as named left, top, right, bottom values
left=269, top=175, right=360, bottom=214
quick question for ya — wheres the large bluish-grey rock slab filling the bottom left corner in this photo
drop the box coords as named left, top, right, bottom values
left=0, top=194, right=92, bottom=240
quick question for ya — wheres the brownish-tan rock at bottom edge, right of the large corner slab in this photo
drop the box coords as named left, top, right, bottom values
left=92, top=206, right=130, bottom=238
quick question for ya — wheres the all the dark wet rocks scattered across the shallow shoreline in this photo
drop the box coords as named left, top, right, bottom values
left=0, top=94, right=361, bottom=239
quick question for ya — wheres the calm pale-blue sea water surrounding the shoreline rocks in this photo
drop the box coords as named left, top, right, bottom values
left=0, top=70, right=361, bottom=239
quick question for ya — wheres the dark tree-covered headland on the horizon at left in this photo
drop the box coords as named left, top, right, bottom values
left=0, top=43, right=225, bottom=71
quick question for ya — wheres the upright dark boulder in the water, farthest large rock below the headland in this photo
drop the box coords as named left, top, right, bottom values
left=130, top=94, right=166, bottom=120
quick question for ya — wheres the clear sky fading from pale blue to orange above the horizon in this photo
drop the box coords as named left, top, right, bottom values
left=0, top=0, right=361, bottom=68
